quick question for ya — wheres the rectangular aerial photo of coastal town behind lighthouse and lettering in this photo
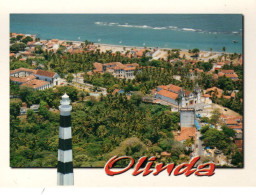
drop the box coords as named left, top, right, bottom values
left=10, top=14, right=244, bottom=168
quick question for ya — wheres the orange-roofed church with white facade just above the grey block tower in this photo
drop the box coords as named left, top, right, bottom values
left=153, top=84, right=201, bottom=107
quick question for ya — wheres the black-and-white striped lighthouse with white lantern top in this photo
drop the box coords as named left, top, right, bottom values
left=57, top=93, right=74, bottom=185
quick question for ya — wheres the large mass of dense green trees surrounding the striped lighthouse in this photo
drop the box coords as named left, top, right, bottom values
left=10, top=87, right=185, bottom=167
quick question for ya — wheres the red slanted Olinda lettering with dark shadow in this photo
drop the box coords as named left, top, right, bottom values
left=105, top=156, right=215, bottom=177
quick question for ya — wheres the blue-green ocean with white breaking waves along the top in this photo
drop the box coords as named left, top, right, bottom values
left=10, top=14, right=243, bottom=53
